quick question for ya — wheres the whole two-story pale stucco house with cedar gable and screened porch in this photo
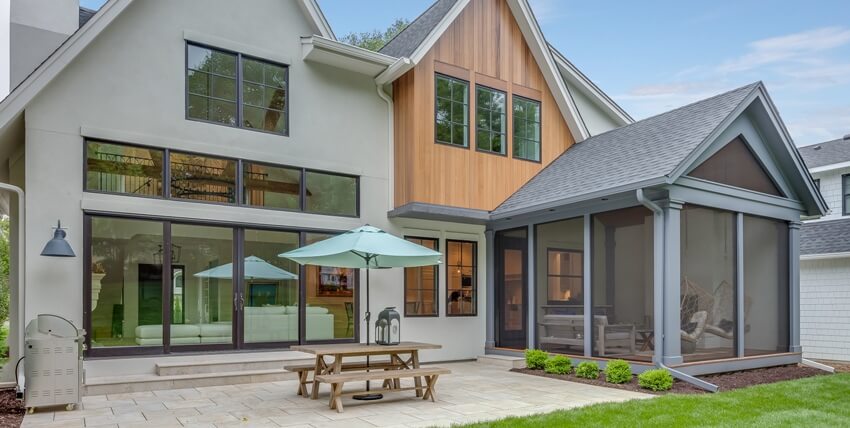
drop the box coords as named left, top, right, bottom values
left=0, top=0, right=826, bottom=392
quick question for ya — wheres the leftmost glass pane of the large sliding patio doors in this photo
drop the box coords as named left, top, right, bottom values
left=87, top=217, right=163, bottom=348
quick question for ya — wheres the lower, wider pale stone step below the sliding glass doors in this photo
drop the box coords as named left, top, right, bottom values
left=83, top=366, right=298, bottom=395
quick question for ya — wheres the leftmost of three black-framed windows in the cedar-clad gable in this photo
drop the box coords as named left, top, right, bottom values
left=434, top=74, right=469, bottom=147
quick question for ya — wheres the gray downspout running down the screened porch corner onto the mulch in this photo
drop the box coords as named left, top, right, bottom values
left=635, top=189, right=719, bottom=392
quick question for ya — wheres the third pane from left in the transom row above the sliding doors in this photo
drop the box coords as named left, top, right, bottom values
left=242, top=162, right=301, bottom=210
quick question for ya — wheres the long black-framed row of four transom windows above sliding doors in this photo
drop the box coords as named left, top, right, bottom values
left=83, top=139, right=360, bottom=217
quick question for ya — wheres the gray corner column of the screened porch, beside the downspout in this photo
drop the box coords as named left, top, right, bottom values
left=654, top=199, right=684, bottom=365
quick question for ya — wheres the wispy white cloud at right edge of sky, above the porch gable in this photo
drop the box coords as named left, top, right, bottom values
left=717, top=27, right=850, bottom=73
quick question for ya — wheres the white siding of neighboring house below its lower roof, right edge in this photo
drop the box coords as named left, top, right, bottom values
left=800, top=258, right=850, bottom=361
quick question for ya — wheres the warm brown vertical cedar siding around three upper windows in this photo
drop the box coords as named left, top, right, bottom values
left=393, top=0, right=574, bottom=211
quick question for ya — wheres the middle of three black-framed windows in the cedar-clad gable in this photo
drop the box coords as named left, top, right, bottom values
left=475, top=86, right=507, bottom=155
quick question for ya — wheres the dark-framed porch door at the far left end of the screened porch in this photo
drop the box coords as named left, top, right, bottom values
left=495, top=228, right=528, bottom=349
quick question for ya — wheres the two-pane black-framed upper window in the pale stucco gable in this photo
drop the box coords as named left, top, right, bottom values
left=186, top=43, right=289, bottom=135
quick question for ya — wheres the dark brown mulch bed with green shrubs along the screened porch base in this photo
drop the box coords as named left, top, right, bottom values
left=511, top=364, right=829, bottom=395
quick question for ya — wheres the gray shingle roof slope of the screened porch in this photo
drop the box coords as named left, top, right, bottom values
left=493, top=82, right=761, bottom=215
